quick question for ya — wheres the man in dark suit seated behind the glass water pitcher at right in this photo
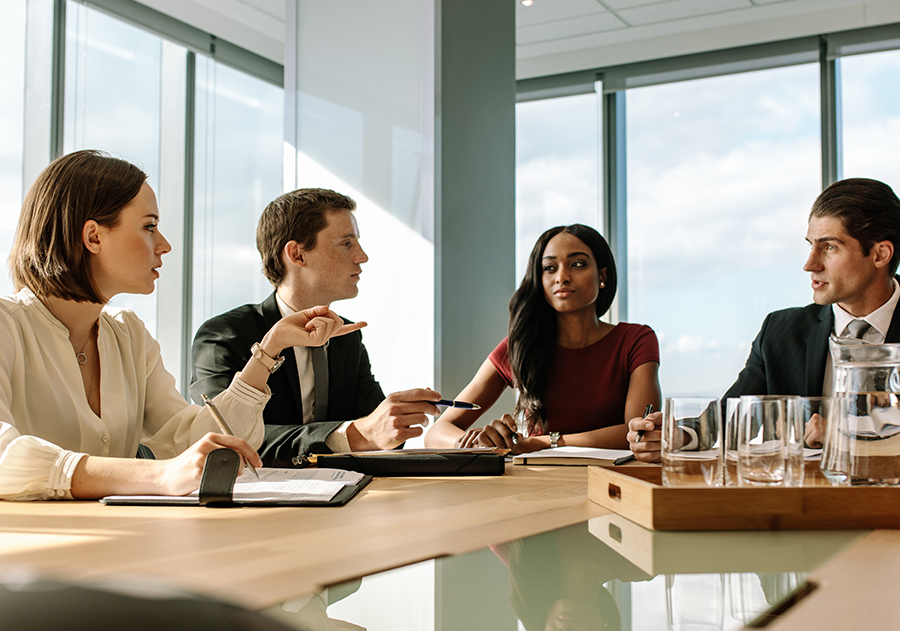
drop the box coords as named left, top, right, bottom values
left=628, top=178, right=900, bottom=462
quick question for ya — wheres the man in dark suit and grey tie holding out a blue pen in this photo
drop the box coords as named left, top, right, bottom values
left=190, top=189, right=440, bottom=467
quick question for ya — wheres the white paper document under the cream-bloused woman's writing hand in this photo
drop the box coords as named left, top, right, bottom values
left=100, top=468, right=365, bottom=504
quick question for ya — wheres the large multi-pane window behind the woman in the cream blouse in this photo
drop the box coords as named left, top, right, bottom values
left=0, top=0, right=283, bottom=388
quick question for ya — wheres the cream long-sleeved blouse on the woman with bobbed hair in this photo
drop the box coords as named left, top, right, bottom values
left=0, top=289, right=270, bottom=500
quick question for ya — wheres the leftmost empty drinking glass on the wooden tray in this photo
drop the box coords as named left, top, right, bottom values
left=662, top=397, right=722, bottom=486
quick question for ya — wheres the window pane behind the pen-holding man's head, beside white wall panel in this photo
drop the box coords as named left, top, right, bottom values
left=191, top=55, right=284, bottom=336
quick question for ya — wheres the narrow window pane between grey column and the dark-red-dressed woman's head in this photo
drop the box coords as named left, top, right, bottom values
left=516, top=94, right=603, bottom=284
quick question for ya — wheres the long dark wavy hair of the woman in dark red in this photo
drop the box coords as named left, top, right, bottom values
left=509, top=223, right=617, bottom=435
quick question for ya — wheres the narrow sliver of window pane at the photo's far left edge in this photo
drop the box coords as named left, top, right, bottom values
left=0, top=2, right=25, bottom=296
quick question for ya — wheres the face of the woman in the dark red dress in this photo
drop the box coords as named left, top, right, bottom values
left=541, top=232, right=606, bottom=313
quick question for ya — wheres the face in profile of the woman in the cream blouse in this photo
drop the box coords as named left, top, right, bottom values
left=87, top=182, right=172, bottom=300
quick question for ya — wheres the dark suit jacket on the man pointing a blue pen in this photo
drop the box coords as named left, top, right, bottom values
left=190, top=292, right=384, bottom=467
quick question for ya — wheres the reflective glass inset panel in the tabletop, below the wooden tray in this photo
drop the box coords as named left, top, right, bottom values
left=266, top=514, right=863, bottom=631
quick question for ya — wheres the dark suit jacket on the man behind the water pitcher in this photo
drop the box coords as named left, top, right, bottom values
left=722, top=304, right=900, bottom=404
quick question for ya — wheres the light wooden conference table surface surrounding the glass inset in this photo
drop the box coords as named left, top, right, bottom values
left=0, top=465, right=900, bottom=630
